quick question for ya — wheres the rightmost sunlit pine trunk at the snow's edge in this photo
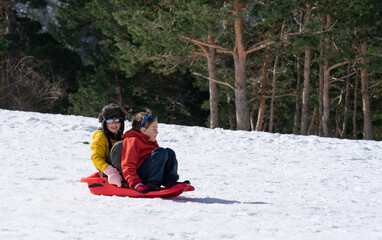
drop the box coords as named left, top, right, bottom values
left=361, top=42, right=373, bottom=140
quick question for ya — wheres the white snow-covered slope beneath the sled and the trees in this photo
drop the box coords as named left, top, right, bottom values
left=0, top=109, right=382, bottom=240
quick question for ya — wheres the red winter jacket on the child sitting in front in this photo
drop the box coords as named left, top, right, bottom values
left=121, top=129, right=159, bottom=185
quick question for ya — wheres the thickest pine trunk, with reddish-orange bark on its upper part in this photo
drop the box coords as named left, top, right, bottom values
left=233, top=0, right=250, bottom=130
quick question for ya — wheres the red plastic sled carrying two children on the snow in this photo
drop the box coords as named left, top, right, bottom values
left=81, top=172, right=195, bottom=198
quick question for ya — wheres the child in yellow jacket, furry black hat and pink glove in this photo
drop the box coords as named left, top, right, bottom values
left=90, top=103, right=126, bottom=187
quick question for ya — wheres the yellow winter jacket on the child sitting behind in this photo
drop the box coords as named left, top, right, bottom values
left=90, top=130, right=117, bottom=172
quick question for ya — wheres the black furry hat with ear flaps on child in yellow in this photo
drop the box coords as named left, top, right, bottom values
left=98, top=103, right=126, bottom=140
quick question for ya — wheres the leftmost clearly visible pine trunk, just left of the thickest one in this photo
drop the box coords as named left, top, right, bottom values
left=207, top=30, right=219, bottom=128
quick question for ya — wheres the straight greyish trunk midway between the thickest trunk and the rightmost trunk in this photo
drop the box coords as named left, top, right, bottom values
left=301, top=3, right=312, bottom=135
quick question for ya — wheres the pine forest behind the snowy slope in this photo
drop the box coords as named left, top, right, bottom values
left=0, top=0, right=382, bottom=140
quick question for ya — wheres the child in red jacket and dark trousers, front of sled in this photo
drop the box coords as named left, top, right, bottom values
left=111, top=112, right=189, bottom=193
